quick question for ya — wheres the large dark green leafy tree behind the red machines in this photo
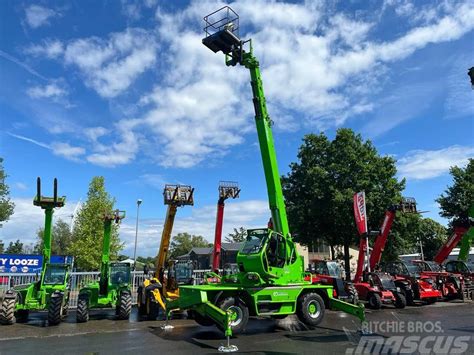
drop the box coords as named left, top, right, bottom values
left=282, top=128, right=405, bottom=279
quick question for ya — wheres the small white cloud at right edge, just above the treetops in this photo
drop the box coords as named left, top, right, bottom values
left=397, top=145, right=474, bottom=180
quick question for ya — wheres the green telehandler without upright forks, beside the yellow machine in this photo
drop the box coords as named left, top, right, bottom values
left=76, top=210, right=132, bottom=323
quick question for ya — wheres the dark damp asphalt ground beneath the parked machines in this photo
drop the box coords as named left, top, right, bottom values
left=0, top=302, right=474, bottom=355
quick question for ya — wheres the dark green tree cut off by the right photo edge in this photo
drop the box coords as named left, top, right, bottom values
left=436, top=158, right=474, bottom=219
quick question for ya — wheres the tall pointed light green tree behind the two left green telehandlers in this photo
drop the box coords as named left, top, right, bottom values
left=69, top=176, right=123, bottom=271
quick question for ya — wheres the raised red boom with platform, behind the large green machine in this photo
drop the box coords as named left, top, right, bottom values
left=212, top=181, right=240, bottom=274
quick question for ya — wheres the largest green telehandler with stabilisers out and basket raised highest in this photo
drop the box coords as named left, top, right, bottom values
left=166, top=6, right=365, bottom=351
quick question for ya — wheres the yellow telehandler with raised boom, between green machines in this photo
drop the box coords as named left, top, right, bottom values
left=137, top=185, right=194, bottom=320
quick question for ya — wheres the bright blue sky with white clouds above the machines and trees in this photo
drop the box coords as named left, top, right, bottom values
left=0, top=0, right=474, bottom=256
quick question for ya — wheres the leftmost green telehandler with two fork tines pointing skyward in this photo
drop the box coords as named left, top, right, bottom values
left=0, top=177, right=70, bottom=325
